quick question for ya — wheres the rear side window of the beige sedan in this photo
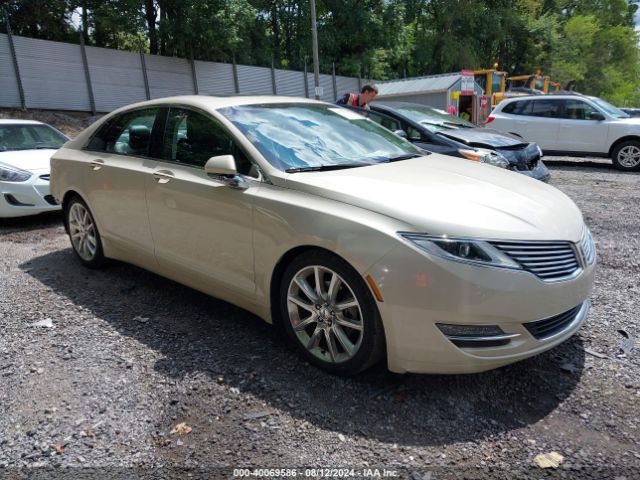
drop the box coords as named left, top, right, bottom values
left=86, top=108, right=159, bottom=156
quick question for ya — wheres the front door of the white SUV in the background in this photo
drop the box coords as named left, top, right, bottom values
left=558, top=98, right=609, bottom=153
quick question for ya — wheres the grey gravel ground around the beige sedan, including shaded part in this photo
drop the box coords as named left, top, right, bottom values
left=0, top=158, right=640, bottom=480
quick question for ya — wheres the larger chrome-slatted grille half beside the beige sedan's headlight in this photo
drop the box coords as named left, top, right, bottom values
left=490, top=241, right=580, bottom=282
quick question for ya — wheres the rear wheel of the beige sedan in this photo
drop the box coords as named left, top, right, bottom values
left=65, top=196, right=105, bottom=268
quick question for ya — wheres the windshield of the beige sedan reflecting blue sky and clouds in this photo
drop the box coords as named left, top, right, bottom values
left=219, top=103, right=424, bottom=172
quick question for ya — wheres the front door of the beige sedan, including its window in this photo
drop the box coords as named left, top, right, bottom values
left=146, top=108, right=260, bottom=297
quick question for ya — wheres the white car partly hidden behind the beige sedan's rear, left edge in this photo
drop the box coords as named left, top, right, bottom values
left=0, top=119, right=69, bottom=218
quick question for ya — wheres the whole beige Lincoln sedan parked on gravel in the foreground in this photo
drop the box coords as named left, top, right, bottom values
left=51, top=96, right=596, bottom=374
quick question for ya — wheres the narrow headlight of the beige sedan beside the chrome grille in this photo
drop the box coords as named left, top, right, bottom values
left=398, top=232, right=522, bottom=270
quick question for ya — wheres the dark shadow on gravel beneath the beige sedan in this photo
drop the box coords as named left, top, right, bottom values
left=20, top=248, right=584, bottom=445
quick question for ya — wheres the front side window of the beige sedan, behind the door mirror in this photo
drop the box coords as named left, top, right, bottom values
left=163, top=107, right=257, bottom=176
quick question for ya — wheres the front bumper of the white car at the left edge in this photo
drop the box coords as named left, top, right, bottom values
left=0, top=174, right=61, bottom=218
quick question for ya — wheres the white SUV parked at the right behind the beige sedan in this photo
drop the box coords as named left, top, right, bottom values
left=487, top=94, right=640, bottom=170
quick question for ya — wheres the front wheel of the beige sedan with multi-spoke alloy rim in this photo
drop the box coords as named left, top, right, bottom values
left=279, top=250, right=384, bottom=375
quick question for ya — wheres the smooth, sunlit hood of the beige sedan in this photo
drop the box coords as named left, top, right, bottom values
left=283, top=154, right=583, bottom=242
